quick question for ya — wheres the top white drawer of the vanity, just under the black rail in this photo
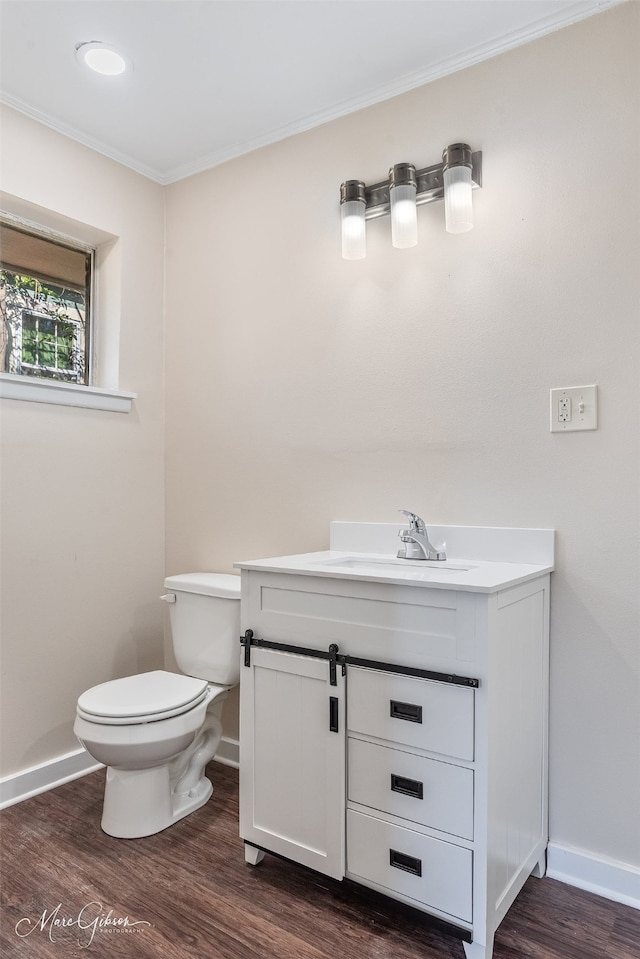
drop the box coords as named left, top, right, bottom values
left=347, top=666, right=475, bottom=760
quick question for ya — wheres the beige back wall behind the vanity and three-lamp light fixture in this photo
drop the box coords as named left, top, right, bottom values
left=166, top=4, right=640, bottom=866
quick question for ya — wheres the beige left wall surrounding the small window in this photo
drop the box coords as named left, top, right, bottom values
left=0, top=110, right=164, bottom=776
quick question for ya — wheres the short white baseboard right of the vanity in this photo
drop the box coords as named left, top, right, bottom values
left=547, top=842, right=640, bottom=909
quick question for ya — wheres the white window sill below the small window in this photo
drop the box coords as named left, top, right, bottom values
left=0, top=373, right=137, bottom=413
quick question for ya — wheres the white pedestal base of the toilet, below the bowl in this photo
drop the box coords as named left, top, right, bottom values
left=101, top=691, right=226, bottom=839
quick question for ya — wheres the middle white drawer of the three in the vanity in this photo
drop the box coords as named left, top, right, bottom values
left=347, top=738, right=473, bottom=839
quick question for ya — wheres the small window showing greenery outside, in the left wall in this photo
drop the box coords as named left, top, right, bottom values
left=0, top=220, right=93, bottom=386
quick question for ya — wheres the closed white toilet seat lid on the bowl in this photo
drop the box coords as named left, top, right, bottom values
left=78, top=669, right=209, bottom=725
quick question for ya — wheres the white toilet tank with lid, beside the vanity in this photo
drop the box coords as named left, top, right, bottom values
left=163, top=573, right=240, bottom=686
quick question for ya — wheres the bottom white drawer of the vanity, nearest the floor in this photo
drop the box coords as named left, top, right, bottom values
left=347, top=809, right=473, bottom=922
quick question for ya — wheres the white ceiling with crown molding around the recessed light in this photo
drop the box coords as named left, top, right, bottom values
left=0, top=0, right=622, bottom=183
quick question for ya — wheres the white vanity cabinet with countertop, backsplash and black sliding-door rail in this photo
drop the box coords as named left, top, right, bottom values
left=236, top=523, right=554, bottom=959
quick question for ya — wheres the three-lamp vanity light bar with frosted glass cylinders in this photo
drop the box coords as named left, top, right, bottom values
left=340, top=143, right=482, bottom=260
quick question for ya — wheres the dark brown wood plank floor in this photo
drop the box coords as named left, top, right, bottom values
left=0, top=763, right=640, bottom=959
